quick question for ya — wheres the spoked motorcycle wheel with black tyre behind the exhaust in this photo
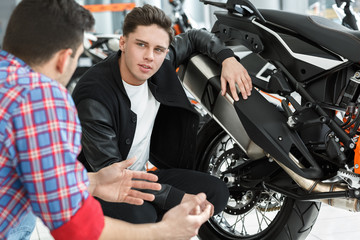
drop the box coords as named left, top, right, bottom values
left=197, top=120, right=321, bottom=240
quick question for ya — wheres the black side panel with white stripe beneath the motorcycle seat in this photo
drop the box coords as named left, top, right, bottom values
left=212, top=11, right=347, bottom=82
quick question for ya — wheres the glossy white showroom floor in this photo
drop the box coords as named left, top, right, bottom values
left=31, top=204, right=360, bottom=240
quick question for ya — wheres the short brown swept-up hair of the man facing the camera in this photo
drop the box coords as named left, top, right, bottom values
left=123, top=4, right=174, bottom=43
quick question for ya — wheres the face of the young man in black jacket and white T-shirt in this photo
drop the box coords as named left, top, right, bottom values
left=120, top=24, right=169, bottom=85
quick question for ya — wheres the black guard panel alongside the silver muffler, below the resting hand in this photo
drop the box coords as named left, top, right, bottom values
left=234, top=91, right=323, bottom=179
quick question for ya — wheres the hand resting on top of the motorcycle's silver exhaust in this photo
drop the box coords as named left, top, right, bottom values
left=221, top=57, right=252, bottom=101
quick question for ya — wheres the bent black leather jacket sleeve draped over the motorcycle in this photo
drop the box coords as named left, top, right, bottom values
left=167, top=29, right=235, bottom=68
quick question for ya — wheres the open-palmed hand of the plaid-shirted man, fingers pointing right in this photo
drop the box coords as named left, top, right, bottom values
left=88, top=157, right=161, bottom=205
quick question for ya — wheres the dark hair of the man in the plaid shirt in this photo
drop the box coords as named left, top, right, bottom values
left=3, top=0, right=95, bottom=65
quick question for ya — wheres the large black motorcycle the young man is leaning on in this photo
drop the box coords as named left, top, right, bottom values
left=178, top=0, right=360, bottom=240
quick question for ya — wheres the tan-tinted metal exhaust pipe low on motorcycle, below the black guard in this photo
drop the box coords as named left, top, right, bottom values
left=274, top=154, right=360, bottom=212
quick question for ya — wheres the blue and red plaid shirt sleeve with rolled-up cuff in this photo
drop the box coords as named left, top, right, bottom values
left=13, top=81, right=93, bottom=230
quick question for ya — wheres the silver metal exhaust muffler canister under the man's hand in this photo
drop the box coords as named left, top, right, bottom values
left=178, top=54, right=265, bottom=160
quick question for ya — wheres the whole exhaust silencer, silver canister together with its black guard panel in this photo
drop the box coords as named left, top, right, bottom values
left=179, top=54, right=322, bottom=179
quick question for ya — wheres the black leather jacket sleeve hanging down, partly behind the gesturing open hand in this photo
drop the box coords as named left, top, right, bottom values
left=77, top=99, right=185, bottom=210
